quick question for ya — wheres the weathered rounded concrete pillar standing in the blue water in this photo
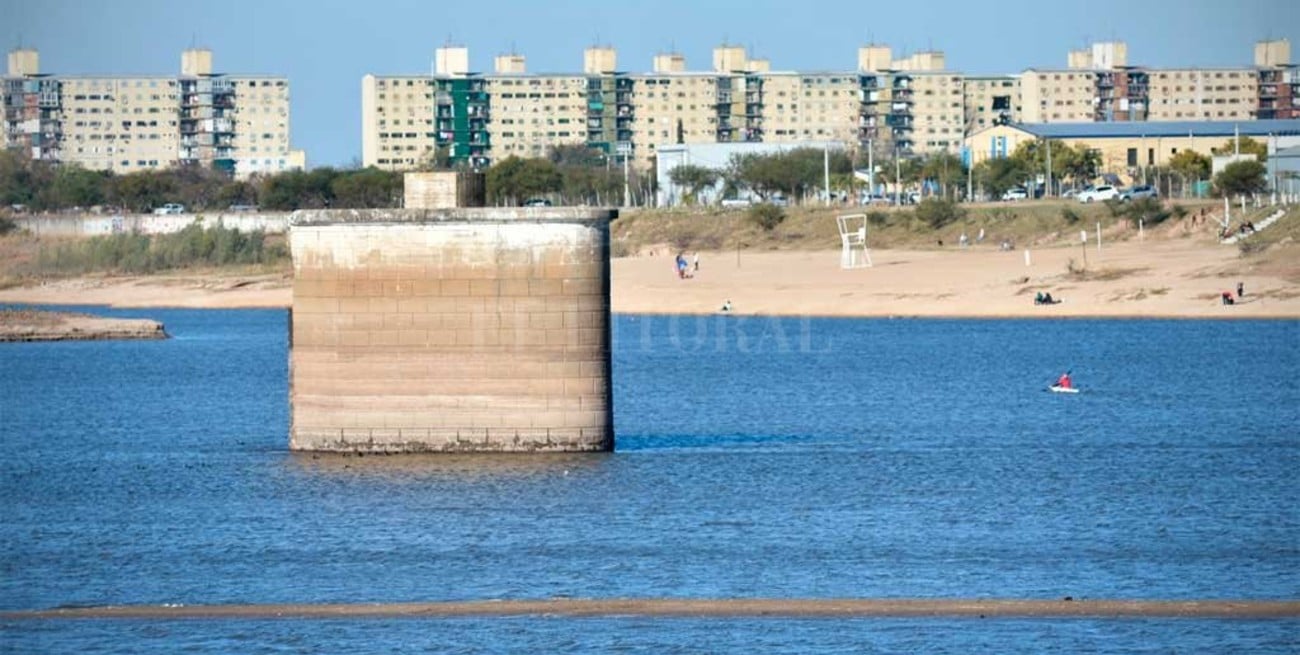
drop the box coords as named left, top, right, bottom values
left=290, top=208, right=618, bottom=452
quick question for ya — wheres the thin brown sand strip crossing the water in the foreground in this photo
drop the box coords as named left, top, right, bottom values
left=0, top=598, right=1300, bottom=620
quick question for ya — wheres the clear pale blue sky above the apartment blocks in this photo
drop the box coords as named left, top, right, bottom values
left=0, top=0, right=1300, bottom=166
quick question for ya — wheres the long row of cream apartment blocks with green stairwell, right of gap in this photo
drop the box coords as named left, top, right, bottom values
left=361, top=40, right=1300, bottom=169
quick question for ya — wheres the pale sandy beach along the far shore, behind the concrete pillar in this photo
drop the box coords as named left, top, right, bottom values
left=0, top=238, right=1300, bottom=318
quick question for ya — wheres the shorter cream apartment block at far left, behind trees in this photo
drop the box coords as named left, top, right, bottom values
left=0, top=49, right=304, bottom=178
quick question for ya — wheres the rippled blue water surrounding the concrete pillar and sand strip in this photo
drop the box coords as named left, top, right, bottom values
left=0, top=308, right=1300, bottom=652
